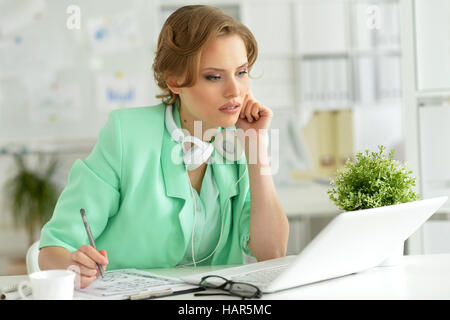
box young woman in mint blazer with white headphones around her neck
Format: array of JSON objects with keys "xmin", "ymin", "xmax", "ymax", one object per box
[{"xmin": 39, "ymin": 5, "xmax": 289, "ymax": 288}]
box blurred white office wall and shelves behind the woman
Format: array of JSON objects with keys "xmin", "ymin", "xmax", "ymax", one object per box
[{"xmin": 0, "ymin": 0, "xmax": 450, "ymax": 275}]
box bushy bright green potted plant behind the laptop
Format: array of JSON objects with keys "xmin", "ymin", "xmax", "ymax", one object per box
[{"xmin": 328, "ymin": 146, "xmax": 420, "ymax": 265}]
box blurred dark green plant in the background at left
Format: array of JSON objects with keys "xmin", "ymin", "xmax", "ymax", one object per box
[{"xmin": 4, "ymin": 153, "xmax": 59, "ymax": 246}]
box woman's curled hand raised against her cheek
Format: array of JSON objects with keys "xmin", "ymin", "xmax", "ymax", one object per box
[{"xmin": 235, "ymin": 91, "xmax": 273, "ymax": 131}]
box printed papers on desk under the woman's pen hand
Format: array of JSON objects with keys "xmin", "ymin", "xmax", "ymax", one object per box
[{"xmin": 76, "ymin": 269, "xmax": 197, "ymax": 299}]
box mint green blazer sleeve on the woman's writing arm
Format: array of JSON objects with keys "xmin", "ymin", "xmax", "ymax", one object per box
[{"xmin": 39, "ymin": 111, "xmax": 122, "ymax": 251}]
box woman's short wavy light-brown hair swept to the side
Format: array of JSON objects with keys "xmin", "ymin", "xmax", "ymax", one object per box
[{"xmin": 153, "ymin": 5, "xmax": 258, "ymax": 105}]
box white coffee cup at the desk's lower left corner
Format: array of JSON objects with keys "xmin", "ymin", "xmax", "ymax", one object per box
[{"xmin": 18, "ymin": 270, "xmax": 75, "ymax": 300}]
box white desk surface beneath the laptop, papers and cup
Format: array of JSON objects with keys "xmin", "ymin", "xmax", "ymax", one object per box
[{"xmin": 0, "ymin": 254, "xmax": 450, "ymax": 300}]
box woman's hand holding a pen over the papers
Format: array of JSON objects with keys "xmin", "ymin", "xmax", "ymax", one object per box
[{"xmin": 70, "ymin": 245, "xmax": 109, "ymax": 289}]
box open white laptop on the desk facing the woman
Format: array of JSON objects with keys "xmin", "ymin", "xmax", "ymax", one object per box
[{"xmin": 181, "ymin": 196, "xmax": 448, "ymax": 293}]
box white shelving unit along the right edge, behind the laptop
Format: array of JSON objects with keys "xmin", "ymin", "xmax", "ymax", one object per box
[{"xmin": 400, "ymin": 0, "xmax": 450, "ymax": 254}]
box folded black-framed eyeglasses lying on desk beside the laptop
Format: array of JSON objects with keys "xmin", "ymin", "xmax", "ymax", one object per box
[{"xmin": 194, "ymin": 275, "xmax": 262, "ymax": 299}]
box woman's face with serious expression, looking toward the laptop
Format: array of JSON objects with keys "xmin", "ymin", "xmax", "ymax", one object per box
[{"xmin": 172, "ymin": 35, "xmax": 249, "ymax": 130}]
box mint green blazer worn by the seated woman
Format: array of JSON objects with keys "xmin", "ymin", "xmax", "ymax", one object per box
[{"xmin": 40, "ymin": 104, "xmax": 251, "ymax": 270}]
